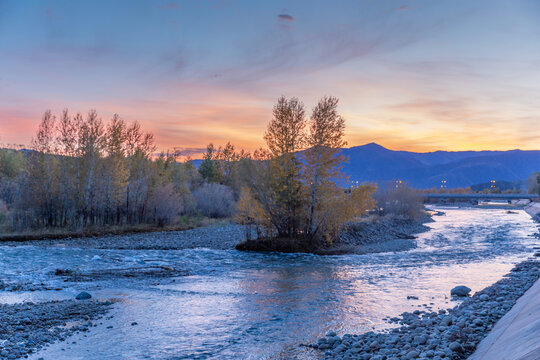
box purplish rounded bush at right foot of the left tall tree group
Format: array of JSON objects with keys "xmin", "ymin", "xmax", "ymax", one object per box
[{"xmin": 149, "ymin": 184, "xmax": 184, "ymax": 226}]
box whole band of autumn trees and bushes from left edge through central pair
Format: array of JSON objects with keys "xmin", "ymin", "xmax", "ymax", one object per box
[{"xmin": 0, "ymin": 96, "xmax": 418, "ymax": 243}]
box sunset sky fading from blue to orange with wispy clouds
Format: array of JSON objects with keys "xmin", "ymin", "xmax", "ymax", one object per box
[{"xmin": 0, "ymin": 0, "xmax": 540, "ymax": 156}]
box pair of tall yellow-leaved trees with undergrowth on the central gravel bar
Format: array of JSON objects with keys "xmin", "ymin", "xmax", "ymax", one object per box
[{"xmin": 243, "ymin": 97, "xmax": 376, "ymax": 249}]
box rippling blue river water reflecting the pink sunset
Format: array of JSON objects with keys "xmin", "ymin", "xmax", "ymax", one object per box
[{"xmin": 0, "ymin": 207, "xmax": 537, "ymax": 359}]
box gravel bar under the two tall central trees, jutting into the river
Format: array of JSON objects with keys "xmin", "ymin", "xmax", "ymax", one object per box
[{"xmin": 236, "ymin": 214, "xmax": 433, "ymax": 255}]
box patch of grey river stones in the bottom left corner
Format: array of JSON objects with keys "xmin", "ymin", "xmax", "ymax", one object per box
[{"xmin": 0, "ymin": 300, "xmax": 112, "ymax": 359}]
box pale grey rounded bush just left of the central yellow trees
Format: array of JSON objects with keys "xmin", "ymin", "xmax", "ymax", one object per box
[{"xmin": 193, "ymin": 183, "xmax": 236, "ymax": 218}]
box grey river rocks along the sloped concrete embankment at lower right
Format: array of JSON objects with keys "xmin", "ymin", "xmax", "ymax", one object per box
[{"xmin": 308, "ymin": 260, "xmax": 540, "ymax": 360}]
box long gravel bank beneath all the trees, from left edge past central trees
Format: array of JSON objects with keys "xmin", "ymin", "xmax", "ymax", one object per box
[{"xmin": 0, "ymin": 215, "xmax": 432, "ymax": 255}]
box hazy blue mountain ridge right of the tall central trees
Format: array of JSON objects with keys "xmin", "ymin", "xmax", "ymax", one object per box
[{"xmin": 343, "ymin": 143, "xmax": 540, "ymax": 188}]
